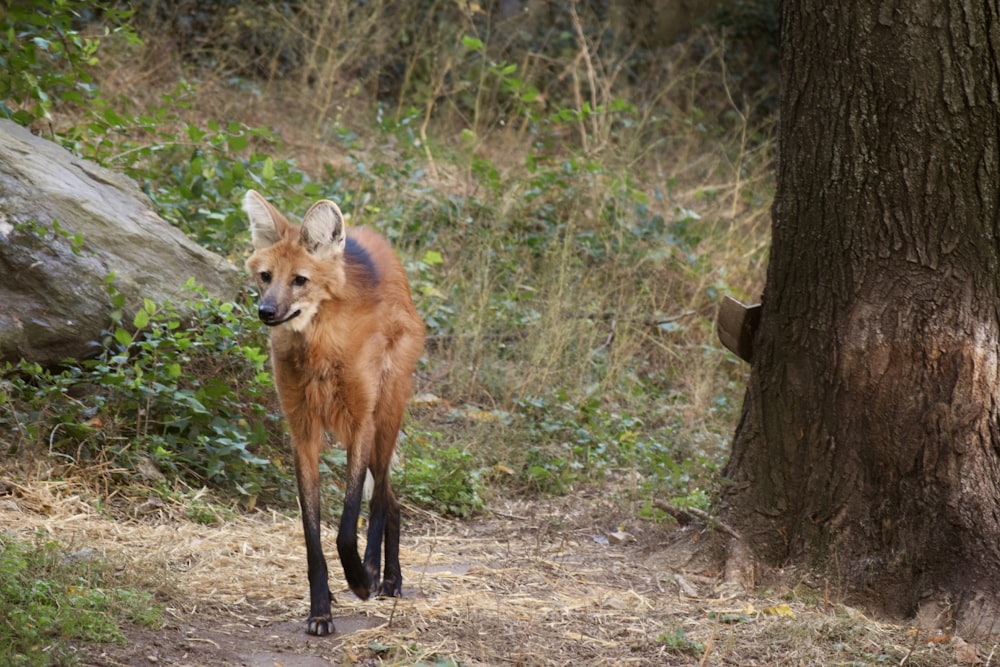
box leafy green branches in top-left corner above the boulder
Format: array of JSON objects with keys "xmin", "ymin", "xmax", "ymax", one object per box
[{"xmin": 0, "ymin": 0, "xmax": 135, "ymax": 125}]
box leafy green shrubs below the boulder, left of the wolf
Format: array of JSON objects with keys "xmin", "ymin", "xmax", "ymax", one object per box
[{"xmin": 0, "ymin": 278, "xmax": 281, "ymax": 503}]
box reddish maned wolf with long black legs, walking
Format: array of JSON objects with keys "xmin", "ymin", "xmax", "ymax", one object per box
[{"xmin": 243, "ymin": 190, "xmax": 424, "ymax": 635}]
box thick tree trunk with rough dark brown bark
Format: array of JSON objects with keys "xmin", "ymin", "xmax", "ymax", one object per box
[{"xmin": 722, "ymin": 0, "xmax": 1000, "ymax": 633}]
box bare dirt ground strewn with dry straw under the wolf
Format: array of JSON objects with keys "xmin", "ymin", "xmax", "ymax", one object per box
[{"xmin": 0, "ymin": 479, "xmax": 984, "ymax": 667}]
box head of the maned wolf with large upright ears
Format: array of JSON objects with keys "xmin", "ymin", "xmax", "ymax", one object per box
[{"xmin": 243, "ymin": 190, "xmax": 347, "ymax": 331}]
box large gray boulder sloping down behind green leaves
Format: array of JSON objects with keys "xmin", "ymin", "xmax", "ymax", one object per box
[{"xmin": 0, "ymin": 120, "xmax": 242, "ymax": 365}]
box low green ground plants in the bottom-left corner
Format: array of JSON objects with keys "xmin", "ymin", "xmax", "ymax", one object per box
[{"xmin": 0, "ymin": 534, "xmax": 163, "ymax": 667}]
